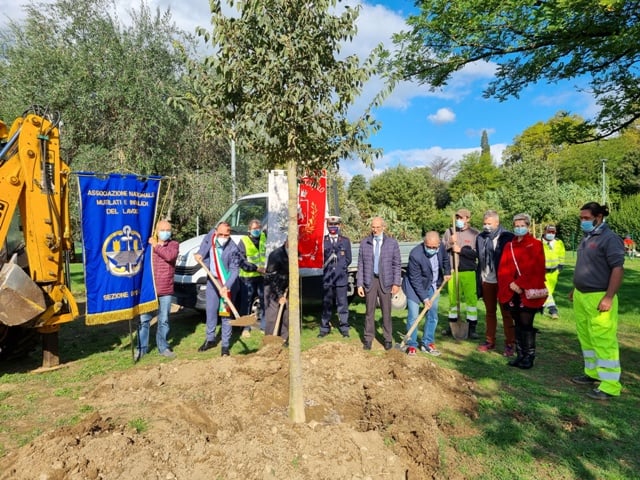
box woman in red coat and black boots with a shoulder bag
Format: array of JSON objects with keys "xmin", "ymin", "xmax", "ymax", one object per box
[{"xmin": 498, "ymin": 213, "xmax": 547, "ymax": 369}]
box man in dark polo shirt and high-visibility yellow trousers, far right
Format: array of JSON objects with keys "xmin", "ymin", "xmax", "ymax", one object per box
[{"xmin": 570, "ymin": 202, "xmax": 624, "ymax": 400}]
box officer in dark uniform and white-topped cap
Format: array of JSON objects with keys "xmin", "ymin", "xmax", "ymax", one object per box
[{"xmin": 318, "ymin": 215, "xmax": 351, "ymax": 338}]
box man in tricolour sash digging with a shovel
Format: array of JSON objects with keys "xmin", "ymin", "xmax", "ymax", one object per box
[{"xmin": 195, "ymin": 222, "xmax": 240, "ymax": 356}]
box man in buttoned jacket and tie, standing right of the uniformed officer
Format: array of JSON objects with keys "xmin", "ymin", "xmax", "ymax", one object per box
[{"xmin": 356, "ymin": 217, "xmax": 402, "ymax": 350}]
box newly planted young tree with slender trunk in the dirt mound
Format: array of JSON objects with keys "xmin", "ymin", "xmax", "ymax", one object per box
[{"xmin": 176, "ymin": 0, "xmax": 379, "ymax": 422}]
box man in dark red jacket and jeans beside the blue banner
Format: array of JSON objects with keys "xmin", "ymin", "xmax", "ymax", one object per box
[{"xmin": 135, "ymin": 220, "xmax": 179, "ymax": 362}]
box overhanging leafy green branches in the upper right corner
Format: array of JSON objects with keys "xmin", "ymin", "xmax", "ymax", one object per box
[{"xmin": 392, "ymin": 0, "xmax": 640, "ymax": 140}]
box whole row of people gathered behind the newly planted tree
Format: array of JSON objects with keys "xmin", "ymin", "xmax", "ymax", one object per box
[{"xmin": 136, "ymin": 202, "xmax": 625, "ymax": 400}]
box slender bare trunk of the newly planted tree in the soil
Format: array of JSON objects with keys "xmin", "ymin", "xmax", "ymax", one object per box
[{"xmin": 287, "ymin": 160, "xmax": 305, "ymax": 423}]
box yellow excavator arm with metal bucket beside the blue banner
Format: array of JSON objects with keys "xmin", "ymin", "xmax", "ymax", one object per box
[{"xmin": 0, "ymin": 106, "xmax": 79, "ymax": 368}]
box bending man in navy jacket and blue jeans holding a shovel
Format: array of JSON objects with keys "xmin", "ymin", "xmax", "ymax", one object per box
[{"xmin": 402, "ymin": 231, "xmax": 451, "ymax": 356}]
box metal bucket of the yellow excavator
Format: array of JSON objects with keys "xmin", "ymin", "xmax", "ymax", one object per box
[{"xmin": 0, "ymin": 263, "xmax": 47, "ymax": 327}]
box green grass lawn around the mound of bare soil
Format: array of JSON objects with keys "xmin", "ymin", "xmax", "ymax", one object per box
[{"xmin": 0, "ymin": 253, "xmax": 640, "ymax": 480}]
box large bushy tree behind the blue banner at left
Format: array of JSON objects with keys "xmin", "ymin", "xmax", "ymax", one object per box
[{"xmin": 0, "ymin": 0, "xmax": 218, "ymax": 236}]
